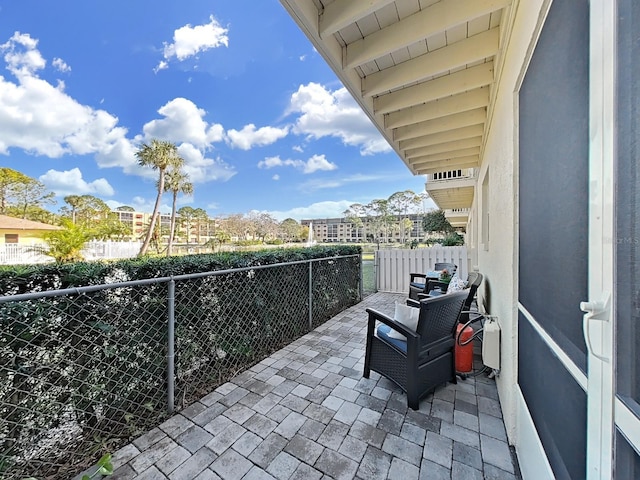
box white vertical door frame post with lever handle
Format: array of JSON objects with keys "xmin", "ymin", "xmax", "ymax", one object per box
[{"xmin": 580, "ymin": 0, "xmax": 617, "ymax": 480}]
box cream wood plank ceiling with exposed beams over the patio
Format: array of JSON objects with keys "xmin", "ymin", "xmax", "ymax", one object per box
[{"xmin": 280, "ymin": 0, "xmax": 511, "ymax": 175}]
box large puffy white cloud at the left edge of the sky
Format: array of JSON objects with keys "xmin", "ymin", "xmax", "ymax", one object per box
[{"xmin": 0, "ymin": 32, "xmax": 135, "ymax": 171}]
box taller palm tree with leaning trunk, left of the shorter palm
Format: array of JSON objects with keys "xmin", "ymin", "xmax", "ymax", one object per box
[{"xmin": 136, "ymin": 138, "xmax": 184, "ymax": 256}]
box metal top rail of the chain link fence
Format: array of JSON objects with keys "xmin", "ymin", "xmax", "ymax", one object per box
[{"xmin": 0, "ymin": 254, "xmax": 360, "ymax": 304}]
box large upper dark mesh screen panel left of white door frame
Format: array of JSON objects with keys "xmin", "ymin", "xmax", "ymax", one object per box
[{"xmin": 519, "ymin": 0, "xmax": 589, "ymax": 370}]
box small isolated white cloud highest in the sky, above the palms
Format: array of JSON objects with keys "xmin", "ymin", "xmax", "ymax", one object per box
[{"xmin": 156, "ymin": 15, "xmax": 229, "ymax": 71}]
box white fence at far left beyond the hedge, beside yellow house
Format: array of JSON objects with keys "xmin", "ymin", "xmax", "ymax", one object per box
[{"xmin": 0, "ymin": 241, "xmax": 142, "ymax": 265}]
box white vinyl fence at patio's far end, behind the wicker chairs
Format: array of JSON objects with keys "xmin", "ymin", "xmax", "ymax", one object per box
[{"xmin": 375, "ymin": 246, "xmax": 469, "ymax": 294}]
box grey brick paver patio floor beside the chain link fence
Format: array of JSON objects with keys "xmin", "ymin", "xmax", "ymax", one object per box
[{"xmin": 110, "ymin": 293, "xmax": 519, "ymax": 480}]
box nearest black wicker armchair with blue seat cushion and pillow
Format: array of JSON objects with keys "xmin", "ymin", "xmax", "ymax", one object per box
[{"xmin": 363, "ymin": 291, "xmax": 468, "ymax": 410}]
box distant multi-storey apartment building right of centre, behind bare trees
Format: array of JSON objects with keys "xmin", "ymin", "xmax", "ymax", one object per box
[{"xmin": 300, "ymin": 213, "xmax": 425, "ymax": 243}]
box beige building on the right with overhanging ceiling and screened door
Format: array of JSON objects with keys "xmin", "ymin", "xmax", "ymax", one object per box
[{"xmin": 281, "ymin": 0, "xmax": 640, "ymax": 480}]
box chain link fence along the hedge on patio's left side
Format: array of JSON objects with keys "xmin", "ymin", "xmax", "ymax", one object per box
[{"xmin": 0, "ymin": 255, "xmax": 362, "ymax": 480}]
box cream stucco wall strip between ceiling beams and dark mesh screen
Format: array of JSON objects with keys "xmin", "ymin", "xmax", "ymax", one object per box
[{"xmin": 470, "ymin": 0, "xmax": 549, "ymax": 446}]
